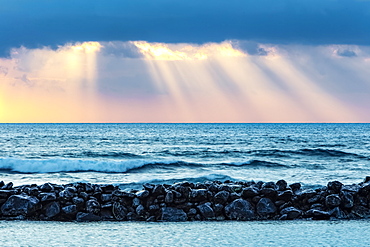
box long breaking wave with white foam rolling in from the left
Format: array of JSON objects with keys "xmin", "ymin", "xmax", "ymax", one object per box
[{"xmin": 0, "ymin": 158, "xmax": 288, "ymax": 173}]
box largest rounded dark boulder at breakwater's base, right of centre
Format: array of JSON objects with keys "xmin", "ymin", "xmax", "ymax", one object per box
[{"xmin": 225, "ymin": 199, "xmax": 255, "ymax": 220}]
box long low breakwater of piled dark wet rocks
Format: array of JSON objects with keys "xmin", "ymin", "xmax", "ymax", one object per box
[{"xmin": 0, "ymin": 177, "xmax": 370, "ymax": 221}]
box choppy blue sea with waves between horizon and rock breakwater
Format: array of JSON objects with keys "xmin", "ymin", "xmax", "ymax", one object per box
[{"xmin": 0, "ymin": 124, "xmax": 370, "ymax": 188}]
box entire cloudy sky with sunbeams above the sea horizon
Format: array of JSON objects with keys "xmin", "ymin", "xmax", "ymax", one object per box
[{"xmin": 0, "ymin": 0, "xmax": 370, "ymax": 123}]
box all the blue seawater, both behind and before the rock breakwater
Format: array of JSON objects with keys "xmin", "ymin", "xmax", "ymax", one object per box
[{"xmin": 0, "ymin": 124, "xmax": 370, "ymax": 246}]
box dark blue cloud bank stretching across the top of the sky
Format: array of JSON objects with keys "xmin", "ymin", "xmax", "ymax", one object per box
[{"xmin": 0, "ymin": 0, "xmax": 370, "ymax": 55}]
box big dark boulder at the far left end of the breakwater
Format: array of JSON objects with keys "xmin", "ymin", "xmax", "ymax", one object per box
[{"xmin": 1, "ymin": 195, "xmax": 41, "ymax": 216}]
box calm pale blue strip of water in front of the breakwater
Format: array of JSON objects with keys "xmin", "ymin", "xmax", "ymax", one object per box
[{"xmin": 0, "ymin": 220, "xmax": 370, "ymax": 246}]
